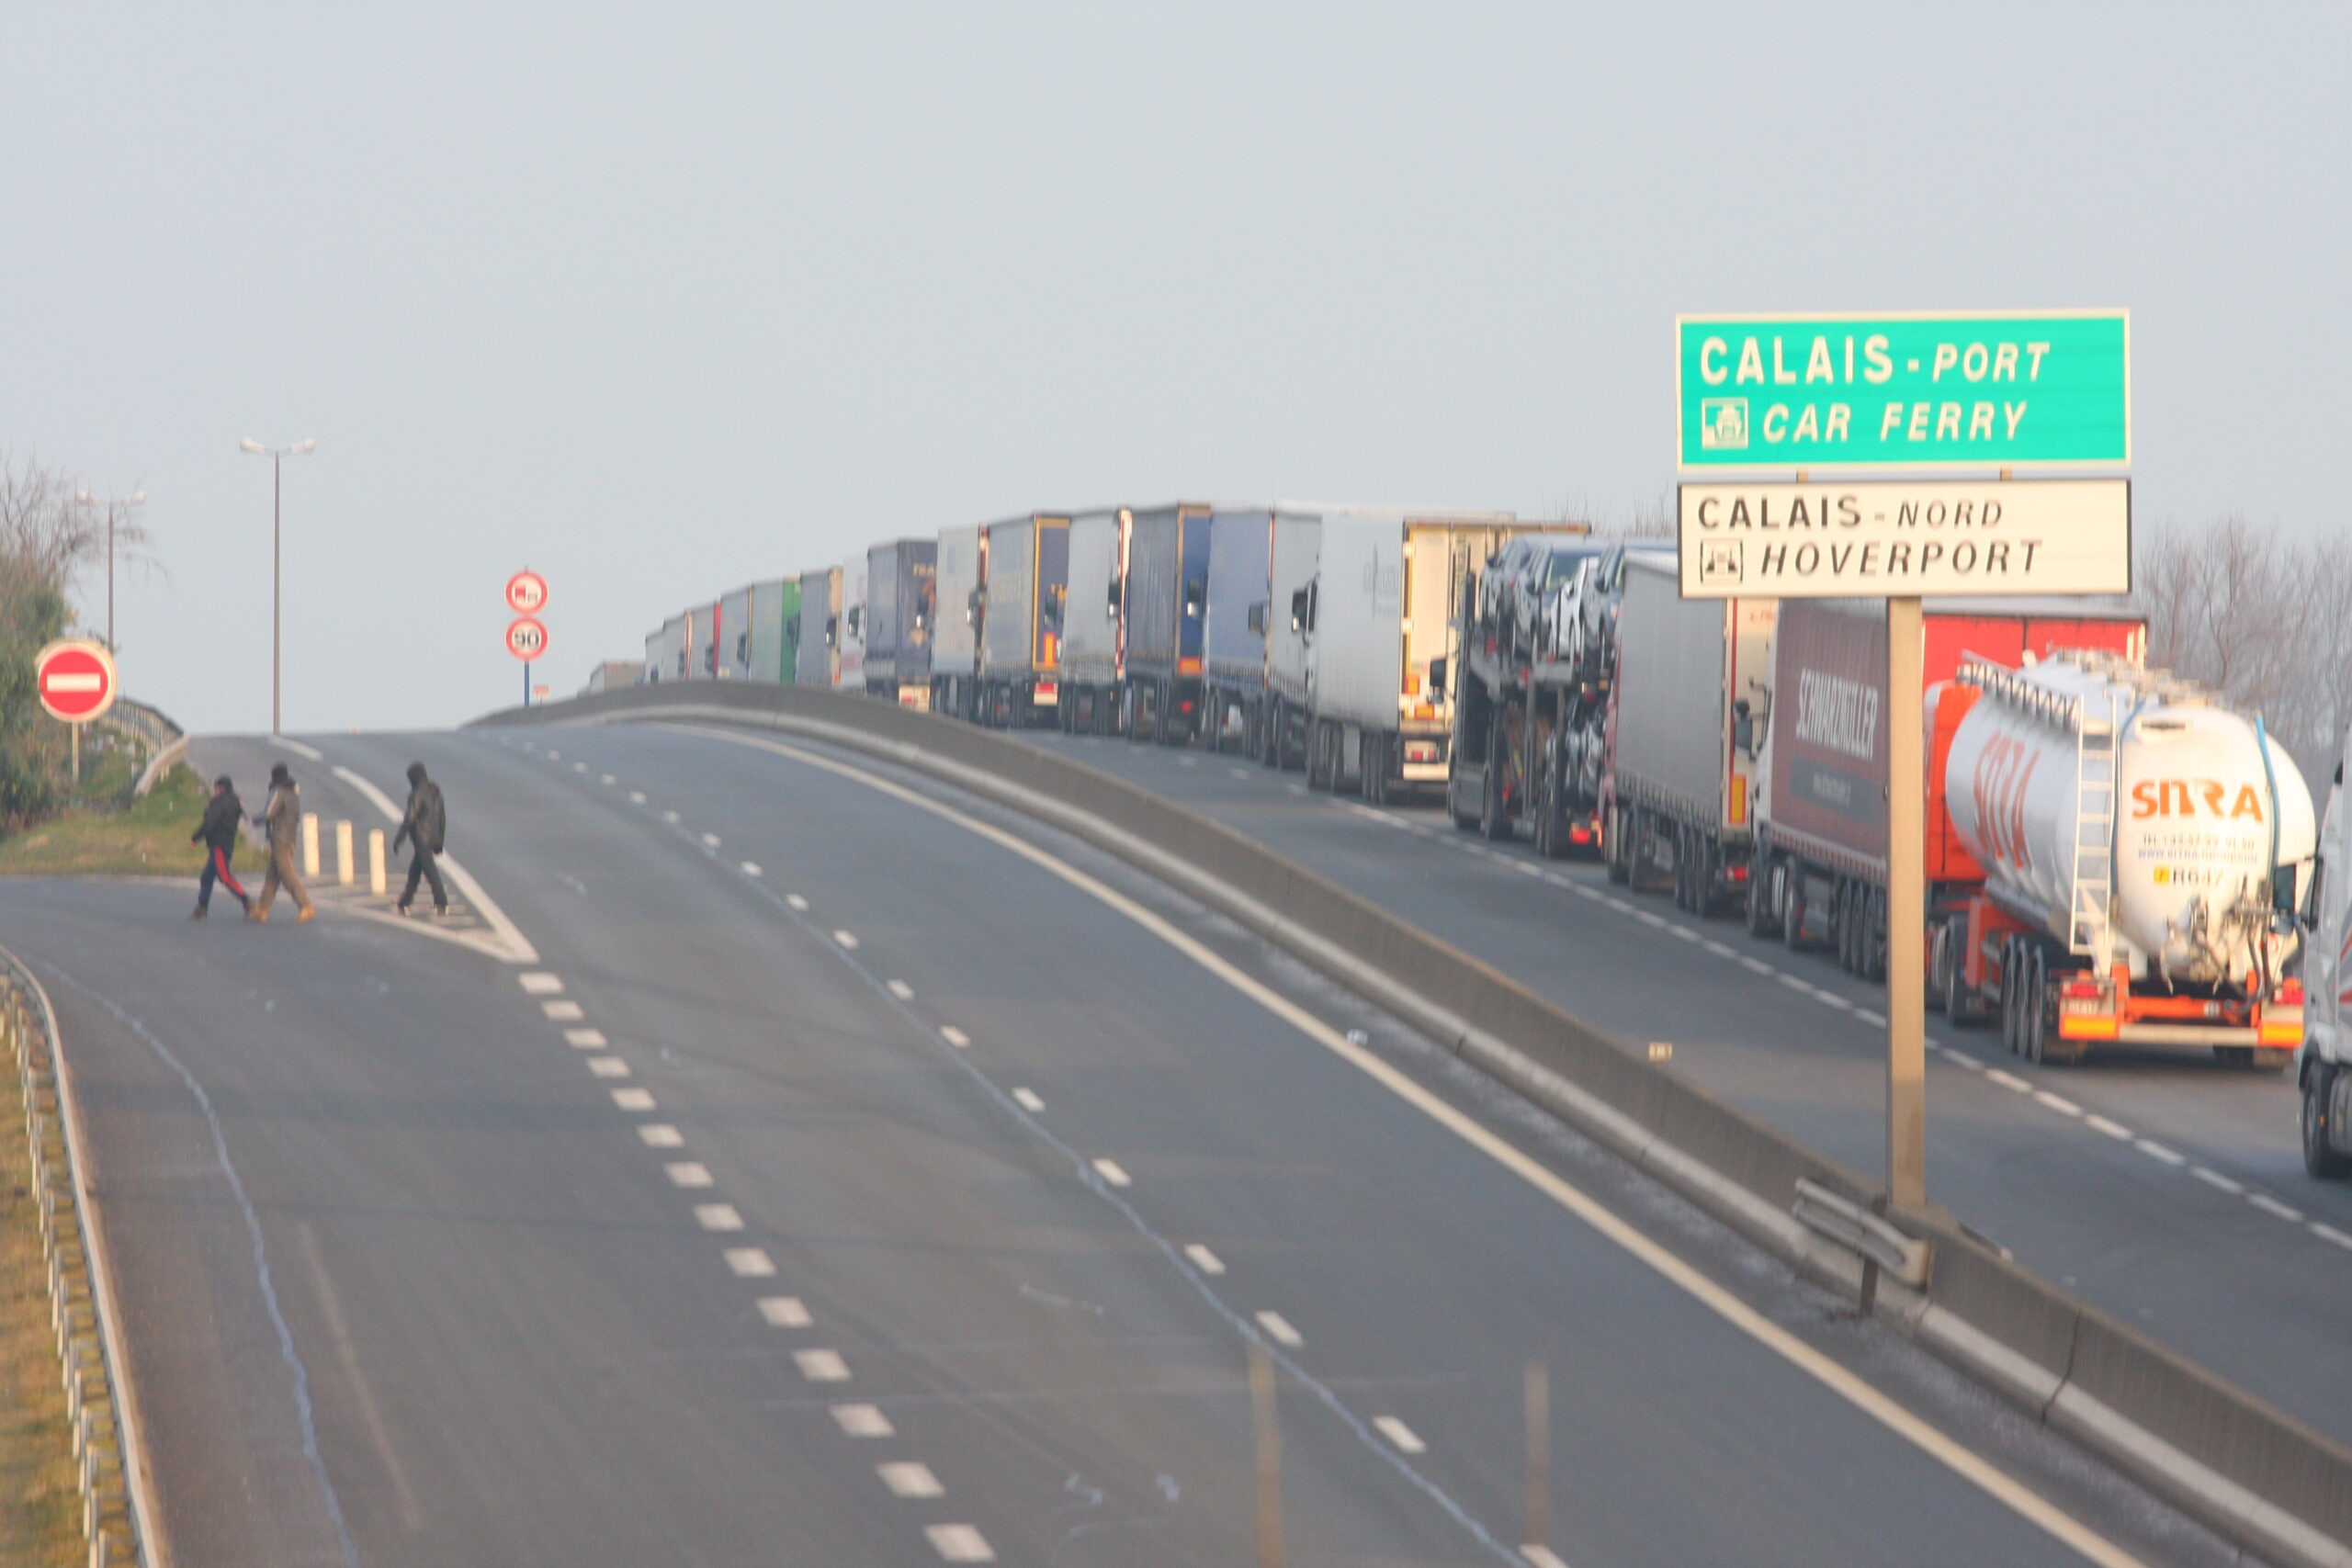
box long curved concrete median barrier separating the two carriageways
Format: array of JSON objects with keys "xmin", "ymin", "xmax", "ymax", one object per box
[{"xmin": 478, "ymin": 682, "xmax": 2352, "ymax": 1568}]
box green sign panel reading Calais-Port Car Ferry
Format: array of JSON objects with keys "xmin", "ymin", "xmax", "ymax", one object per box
[{"xmin": 1675, "ymin": 310, "xmax": 2131, "ymax": 468}]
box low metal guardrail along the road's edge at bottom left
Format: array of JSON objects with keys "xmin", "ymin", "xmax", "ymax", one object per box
[{"xmin": 0, "ymin": 950, "xmax": 151, "ymax": 1568}]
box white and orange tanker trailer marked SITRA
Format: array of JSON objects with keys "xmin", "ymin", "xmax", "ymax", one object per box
[{"xmin": 1928, "ymin": 651, "xmax": 2319, "ymax": 1072}]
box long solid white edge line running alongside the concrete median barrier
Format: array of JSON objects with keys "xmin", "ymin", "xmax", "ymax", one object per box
[{"xmin": 694, "ymin": 728, "xmax": 2143, "ymax": 1568}]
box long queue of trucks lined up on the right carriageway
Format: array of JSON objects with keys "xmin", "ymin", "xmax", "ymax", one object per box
[{"xmin": 644, "ymin": 501, "xmax": 2324, "ymax": 1123}]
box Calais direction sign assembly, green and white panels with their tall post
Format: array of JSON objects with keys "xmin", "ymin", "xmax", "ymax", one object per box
[{"xmin": 1675, "ymin": 310, "xmax": 2131, "ymax": 1211}]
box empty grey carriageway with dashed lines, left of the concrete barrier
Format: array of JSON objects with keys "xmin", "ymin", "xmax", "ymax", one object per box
[{"xmin": 0, "ymin": 728, "xmax": 2232, "ymax": 1568}]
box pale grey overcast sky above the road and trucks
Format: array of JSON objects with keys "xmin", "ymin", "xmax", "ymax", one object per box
[{"xmin": 0, "ymin": 0, "xmax": 2352, "ymax": 731}]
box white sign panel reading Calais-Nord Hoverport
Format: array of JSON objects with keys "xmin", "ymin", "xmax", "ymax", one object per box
[{"xmin": 1679, "ymin": 479, "xmax": 2131, "ymax": 600}]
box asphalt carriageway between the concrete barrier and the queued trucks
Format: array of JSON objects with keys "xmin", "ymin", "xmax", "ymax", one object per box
[{"xmin": 1011, "ymin": 733, "xmax": 2352, "ymax": 1441}]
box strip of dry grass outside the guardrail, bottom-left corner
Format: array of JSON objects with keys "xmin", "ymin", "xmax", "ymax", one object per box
[{"xmin": 0, "ymin": 1058, "xmax": 89, "ymax": 1568}]
